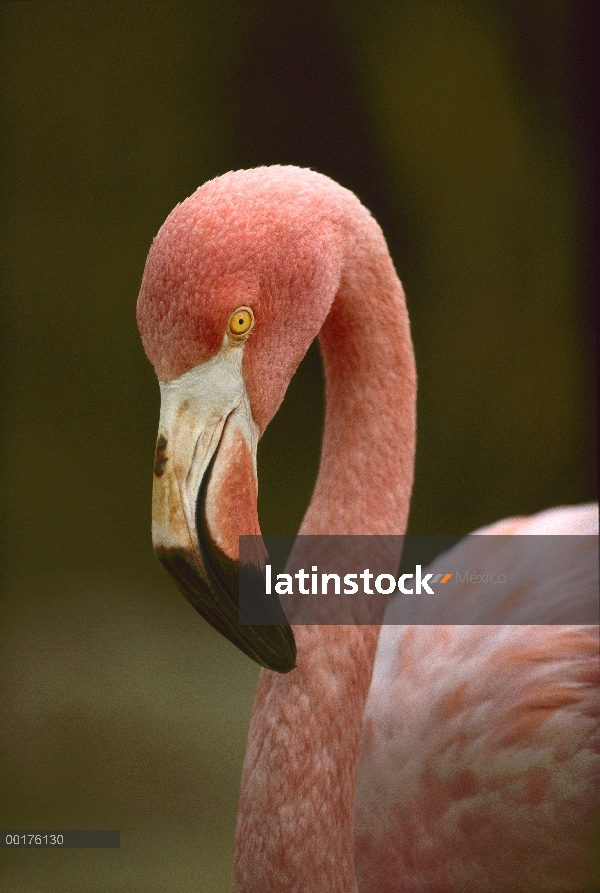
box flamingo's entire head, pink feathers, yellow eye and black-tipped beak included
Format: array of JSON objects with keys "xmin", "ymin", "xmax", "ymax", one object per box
[{"xmin": 137, "ymin": 167, "xmax": 346, "ymax": 672}]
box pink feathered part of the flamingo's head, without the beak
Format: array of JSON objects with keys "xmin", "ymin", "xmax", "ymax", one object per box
[{"xmin": 137, "ymin": 166, "xmax": 370, "ymax": 433}]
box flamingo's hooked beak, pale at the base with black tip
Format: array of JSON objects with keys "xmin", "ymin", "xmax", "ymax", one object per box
[{"xmin": 152, "ymin": 342, "xmax": 296, "ymax": 673}]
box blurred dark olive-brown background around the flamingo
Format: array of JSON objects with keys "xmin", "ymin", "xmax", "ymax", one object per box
[{"xmin": 0, "ymin": 0, "xmax": 596, "ymax": 893}]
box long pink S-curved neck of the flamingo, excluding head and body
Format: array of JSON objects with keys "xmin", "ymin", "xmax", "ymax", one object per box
[{"xmin": 233, "ymin": 218, "xmax": 416, "ymax": 893}]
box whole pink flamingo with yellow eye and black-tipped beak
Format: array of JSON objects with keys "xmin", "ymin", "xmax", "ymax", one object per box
[{"xmin": 137, "ymin": 166, "xmax": 600, "ymax": 893}]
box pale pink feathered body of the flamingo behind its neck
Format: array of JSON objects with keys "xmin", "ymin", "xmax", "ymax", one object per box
[{"xmin": 355, "ymin": 506, "xmax": 600, "ymax": 893}]
